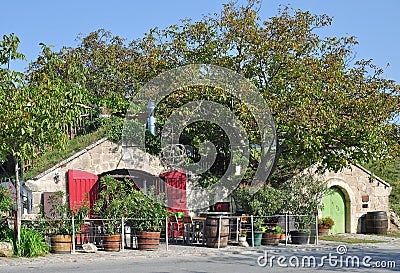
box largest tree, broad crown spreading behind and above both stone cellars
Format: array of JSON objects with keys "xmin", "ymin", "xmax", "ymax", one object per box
[{"xmin": 60, "ymin": 1, "xmax": 400, "ymax": 181}]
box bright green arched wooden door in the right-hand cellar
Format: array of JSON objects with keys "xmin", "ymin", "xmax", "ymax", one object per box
[{"xmin": 322, "ymin": 188, "xmax": 346, "ymax": 234}]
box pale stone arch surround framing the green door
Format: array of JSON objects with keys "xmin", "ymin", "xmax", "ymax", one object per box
[{"xmin": 320, "ymin": 178, "xmax": 357, "ymax": 233}]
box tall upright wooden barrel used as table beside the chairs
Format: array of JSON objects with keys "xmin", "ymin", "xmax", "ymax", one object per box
[{"xmin": 204, "ymin": 215, "xmax": 229, "ymax": 247}]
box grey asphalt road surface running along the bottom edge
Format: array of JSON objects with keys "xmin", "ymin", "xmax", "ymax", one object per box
[{"xmin": 0, "ymin": 247, "xmax": 400, "ymax": 273}]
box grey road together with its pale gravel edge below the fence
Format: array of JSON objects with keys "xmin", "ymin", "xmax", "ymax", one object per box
[{"xmin": 0, "ymin": 234, "xmax": 400, "ymax": 273}]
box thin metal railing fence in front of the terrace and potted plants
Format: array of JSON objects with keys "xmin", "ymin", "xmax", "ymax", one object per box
[{"xmin": 11, "ymin": 214, "xmax": 318, "ymax": 253}]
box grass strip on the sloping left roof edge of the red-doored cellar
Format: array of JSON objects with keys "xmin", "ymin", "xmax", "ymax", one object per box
[{"xmin": 24, "ymin": 129, "xmax": 104, "ymax": 179}]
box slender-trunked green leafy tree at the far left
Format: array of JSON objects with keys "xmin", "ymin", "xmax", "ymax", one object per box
[{"xmin": 0, "ymin": 35, "xmax": 88, "ymax": 240}]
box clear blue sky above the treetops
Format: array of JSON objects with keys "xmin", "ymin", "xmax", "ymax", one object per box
[{"xmin": 0, "ymin": 0, "xmax": 400, "ymax": 82}]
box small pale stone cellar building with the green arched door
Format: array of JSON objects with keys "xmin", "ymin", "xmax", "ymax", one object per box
[{"xmin": 311, "ymin": 165, "xmax": 392, "ymax": 233}]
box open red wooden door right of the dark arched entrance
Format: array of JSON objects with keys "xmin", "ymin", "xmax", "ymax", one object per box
[{"xmin": 160, "ymin": 171, "xmax": 187, "ymax": 211}]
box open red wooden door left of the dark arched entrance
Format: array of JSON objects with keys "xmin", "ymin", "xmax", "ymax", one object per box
[{"xmin": 68, "ymin": 170, "xmax": 99, "ymax": 209}]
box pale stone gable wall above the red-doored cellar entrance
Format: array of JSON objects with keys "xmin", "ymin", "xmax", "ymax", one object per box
[{"xmin": 26, "ymin": 138, "xmax": 164, "ymax": 213}]
